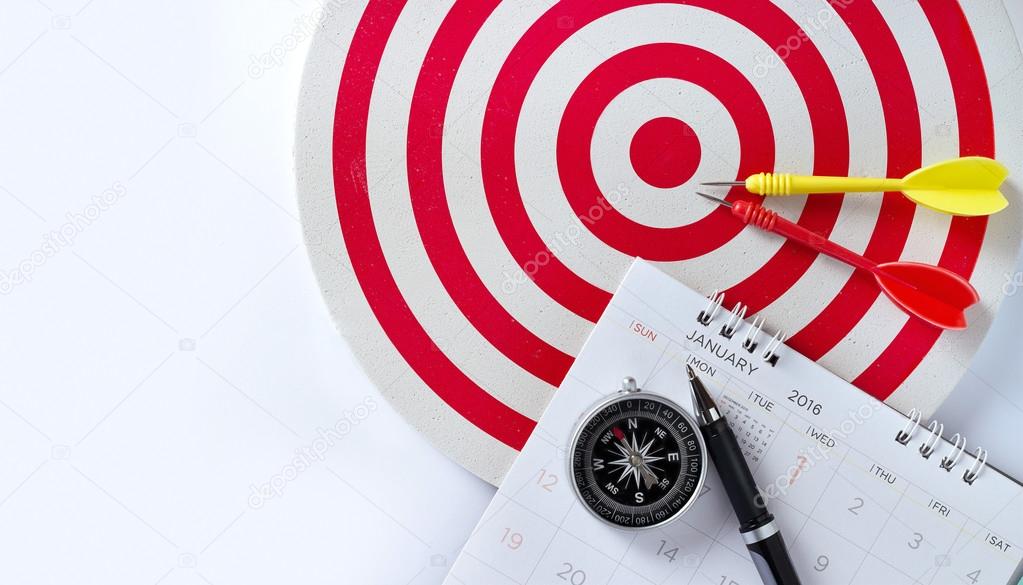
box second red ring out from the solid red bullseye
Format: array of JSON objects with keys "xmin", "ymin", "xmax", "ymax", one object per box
[{"xmin": 481, "ymin": 0, "xmax": 849, "ymax": 320}]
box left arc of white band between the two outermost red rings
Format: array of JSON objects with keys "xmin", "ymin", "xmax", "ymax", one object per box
[{"xmin": 366, "ymin": 3, "xmax": 553, "ymax": 419}]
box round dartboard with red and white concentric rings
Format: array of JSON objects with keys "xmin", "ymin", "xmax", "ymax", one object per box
[{"xmin": 297, "ymin": 0, "xmax": 1023, "ymax": 482}]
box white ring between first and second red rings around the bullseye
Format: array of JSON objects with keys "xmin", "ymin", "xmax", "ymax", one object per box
[{"xmin": 516, "ymin": 4, "xmax": 811, "ymax": 290}]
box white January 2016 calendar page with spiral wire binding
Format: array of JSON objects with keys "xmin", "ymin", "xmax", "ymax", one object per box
[{"xmin": 445, "ymin": 261, "xmax": 1023, "ymax": 585}]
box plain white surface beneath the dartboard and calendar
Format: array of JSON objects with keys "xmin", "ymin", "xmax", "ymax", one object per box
[{"xmin": 0, "ymin": 0, "xmax": 1023, "ymax": 585}]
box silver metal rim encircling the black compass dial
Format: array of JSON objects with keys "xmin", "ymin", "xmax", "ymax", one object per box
[{"xmin": 566, "ymin": 389, "xmax": 710, "ymax": 531}]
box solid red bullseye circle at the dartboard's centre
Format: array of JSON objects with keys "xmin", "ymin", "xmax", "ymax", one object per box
[{"xmin": 629, "ymin": 117, "xmax": 702, "ymax": 189}]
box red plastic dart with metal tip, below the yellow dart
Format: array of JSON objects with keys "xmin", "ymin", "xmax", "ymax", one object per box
[{"xmin": 697, "ymin": 193, "xmax": 980, "ymax": 329}]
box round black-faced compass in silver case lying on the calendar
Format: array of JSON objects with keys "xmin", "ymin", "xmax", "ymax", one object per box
[{"xmin": 570, "ymin": 377, "xmax": 707, "ymax": 528}]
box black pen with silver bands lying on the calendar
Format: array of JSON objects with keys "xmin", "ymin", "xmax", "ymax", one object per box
[{"xmin": 685, "ymin": 365, "xmax": 800, "ymax": 585}]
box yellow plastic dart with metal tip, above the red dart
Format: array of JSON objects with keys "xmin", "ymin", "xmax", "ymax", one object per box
[{"xmin": 704, "ymin": 156, "xmax": 1009, "ymax": 216}]
